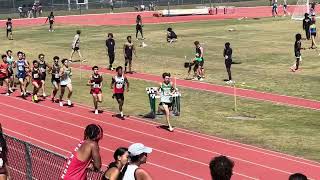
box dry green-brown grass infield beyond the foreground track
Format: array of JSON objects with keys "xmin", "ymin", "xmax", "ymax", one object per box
[{"xmin": 0, "ymin": 18, "xmax": 320, "ymax": 161}]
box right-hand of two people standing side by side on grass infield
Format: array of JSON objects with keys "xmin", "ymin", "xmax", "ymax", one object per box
[{"xmin": 123, "ymin": 36, "xmax": 137, "ymax": 74}]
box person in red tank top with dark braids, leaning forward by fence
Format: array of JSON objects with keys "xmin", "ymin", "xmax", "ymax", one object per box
[{"xmin": 61, "ymin": 124, "xmax": 103, "ymax": 180}]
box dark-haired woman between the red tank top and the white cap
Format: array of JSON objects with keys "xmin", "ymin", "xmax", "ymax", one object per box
[{"xmin": 101, "ymin": 147, "xmax": 129, "ymax": 180}]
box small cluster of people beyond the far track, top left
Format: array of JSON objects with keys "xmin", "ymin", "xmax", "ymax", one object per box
[{"xmin": 18, "ymin": 2, "xmax": 43, "ymax": 18}]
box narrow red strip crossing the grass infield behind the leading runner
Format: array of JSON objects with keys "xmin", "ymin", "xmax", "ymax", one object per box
[{"xmin": 73, "ymin": 64, "xmax": 320, "ymax": 110}]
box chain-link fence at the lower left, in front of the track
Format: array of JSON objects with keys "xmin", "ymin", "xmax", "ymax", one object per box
[{"xmin": 4, "ymin": 135, "xmax": 102, "ymax": 180}]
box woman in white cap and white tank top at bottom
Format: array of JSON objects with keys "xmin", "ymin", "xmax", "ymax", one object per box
[{"xmin": 123, "ymin": 143, "xmax": 152, "ymax": 180}]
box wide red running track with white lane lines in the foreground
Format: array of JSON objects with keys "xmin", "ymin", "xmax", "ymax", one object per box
[{"xmin": 0, "ymin": 90, "xmax": 320, "ymax": 180}]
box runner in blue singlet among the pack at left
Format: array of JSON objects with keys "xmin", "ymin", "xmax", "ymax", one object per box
[{"xmin": 17, "ymin": 51, "xmax": 28, "ymax": 97}]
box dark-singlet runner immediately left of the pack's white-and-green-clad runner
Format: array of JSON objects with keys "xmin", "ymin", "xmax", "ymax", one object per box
[{"xmin": 49, "ymin": 56, "xmax": 60, "ymax": 102}]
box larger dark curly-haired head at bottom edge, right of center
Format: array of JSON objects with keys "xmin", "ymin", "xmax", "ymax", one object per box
[{"xmin": 209, "ymin": 156, "xmax": 234, "ymax": 180}]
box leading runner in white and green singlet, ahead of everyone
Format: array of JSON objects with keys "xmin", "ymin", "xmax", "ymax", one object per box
[{"xmin": 159, "ymin": 73, "xmax": 175, "ymax": 132}]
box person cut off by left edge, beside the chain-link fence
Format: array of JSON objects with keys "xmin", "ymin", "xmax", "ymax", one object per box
[{"xmin": 0, "ymin": 124, "xmax": 11, "ymax": 180}]
